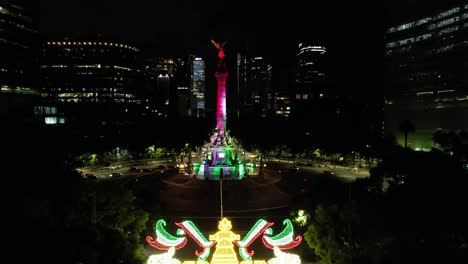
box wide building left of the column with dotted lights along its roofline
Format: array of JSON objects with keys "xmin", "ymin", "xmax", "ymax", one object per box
[{"xmin": 40, "ymin": 40, "xmax": 141, "ymax": 120}]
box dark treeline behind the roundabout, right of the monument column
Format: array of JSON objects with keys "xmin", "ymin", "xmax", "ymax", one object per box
[{"xmin": 228, "ymin": 117, "xmax": 380, "ymax": 153}]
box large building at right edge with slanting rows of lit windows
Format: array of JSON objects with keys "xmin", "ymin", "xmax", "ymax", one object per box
[{"xmin": 385, "ymin": 4, "xmax": 468, "ymax": 149}]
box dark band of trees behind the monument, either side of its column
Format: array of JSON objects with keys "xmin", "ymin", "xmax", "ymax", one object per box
[{"xmin": 8, "ymin": 115, "xmax": 380, "ymax": 155}]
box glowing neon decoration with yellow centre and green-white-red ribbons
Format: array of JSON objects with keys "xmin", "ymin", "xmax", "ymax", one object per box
[{"xmin": 146, "ymin": 218, "xmax": 302, "ymax": 264}]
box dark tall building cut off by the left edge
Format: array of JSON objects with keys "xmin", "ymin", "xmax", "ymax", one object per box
[{"xmin": 0, "ymin": 0, "xmax": 40, "ymax": 115}]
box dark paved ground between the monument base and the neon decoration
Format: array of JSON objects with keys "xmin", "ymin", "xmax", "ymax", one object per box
[{"xmin": 161, "ymin": 169, "xmax": 290, "ymax": 215}]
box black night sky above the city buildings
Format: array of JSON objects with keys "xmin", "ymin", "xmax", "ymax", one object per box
[{"xmin": 40, "ymin": 0, "xmax": 464, "ymax": 103}]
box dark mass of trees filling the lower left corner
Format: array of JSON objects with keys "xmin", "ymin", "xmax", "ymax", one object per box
[{"xmin": 1, "ymin": 120, "xmax": 159, "ymax": 263}]
